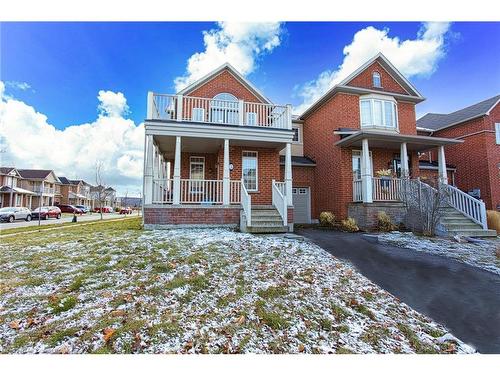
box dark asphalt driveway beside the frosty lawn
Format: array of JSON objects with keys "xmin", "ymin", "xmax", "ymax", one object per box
[{"xmin": 298, "ymin": 228, "xmax": 500, "ymax": 353}]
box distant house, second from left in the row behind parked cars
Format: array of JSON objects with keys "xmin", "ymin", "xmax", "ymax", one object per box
[{"xmin": 17, "ymin": 169, "xmax": 61, "ymax": 209}]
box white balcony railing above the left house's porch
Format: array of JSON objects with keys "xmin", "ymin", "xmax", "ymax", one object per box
[{"xmin": 148, "ymin": 92, "xmax": 292, "ymax": 129}]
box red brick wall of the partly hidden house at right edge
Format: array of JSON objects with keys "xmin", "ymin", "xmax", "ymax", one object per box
[{"xmin": 433, "ymin": 105, "xmax": 500, "ymax": 209}]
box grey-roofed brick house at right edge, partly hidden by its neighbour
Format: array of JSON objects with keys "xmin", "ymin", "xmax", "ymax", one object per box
[{"xmin": 417, "ymin": 95, "xmax": 500, "ymax": 210}]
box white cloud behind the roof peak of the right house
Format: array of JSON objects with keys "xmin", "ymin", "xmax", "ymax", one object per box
[{"xmin": 295, "ymin": 22, "xmax": 450, "ymax": 113}]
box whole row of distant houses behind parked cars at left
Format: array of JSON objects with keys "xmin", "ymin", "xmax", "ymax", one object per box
[{"xmin": 0, "ymin": 167, "xmax": 120, "ymax": 209}]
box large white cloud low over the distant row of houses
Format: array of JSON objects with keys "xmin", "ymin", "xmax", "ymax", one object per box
[{"xmin": 0, "ymin": 81, "xmax": 144, "ymax": 196}]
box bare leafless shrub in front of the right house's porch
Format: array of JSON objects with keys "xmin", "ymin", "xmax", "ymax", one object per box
[{"xmin": 402, "ymin": 179, "xmax": 449, "ymax": 236}]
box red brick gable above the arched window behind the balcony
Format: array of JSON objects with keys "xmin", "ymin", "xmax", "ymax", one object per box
[{"xmin": 188, "ymin": 70, "xmax": 262, "ymax": 103}]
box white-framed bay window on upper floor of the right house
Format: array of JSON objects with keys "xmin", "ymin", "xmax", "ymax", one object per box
[{"xmin": 360, "ymin": 98, "xmax": 398, "ymax": 129}]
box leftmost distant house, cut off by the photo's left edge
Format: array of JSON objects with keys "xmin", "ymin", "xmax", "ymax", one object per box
[{"xmin": 0, "ymin": 167, "xmax": 36, "ymax": 208}]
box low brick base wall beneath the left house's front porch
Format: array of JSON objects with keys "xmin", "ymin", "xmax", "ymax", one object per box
[{"xmin": 144, "ymin": 206, "xmax": 240, "ymax": 225}]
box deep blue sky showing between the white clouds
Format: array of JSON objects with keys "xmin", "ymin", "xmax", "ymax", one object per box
[{"xmin": 0, "ymin": 22, "xmax": 500, "ymax": 128}]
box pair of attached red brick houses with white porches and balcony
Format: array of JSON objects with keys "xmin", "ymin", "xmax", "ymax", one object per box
[{"xmin": 143, "ymin": 54, "xmax": 494, "ymax": 235}]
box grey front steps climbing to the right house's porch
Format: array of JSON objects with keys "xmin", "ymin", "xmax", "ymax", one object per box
[{"xmin": 440, "ymin": 207, "xmax": 497, "ymax": 237}]
